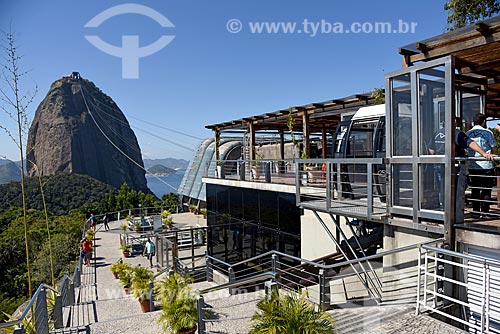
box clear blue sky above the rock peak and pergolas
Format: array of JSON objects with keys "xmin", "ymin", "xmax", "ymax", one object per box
[{"xmin": 0, "ymin": 0, "xmax": 446, "ymax": 160}]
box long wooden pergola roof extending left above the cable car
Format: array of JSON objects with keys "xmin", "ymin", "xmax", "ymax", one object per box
[{"xmin": 205, "ymin": 92, "xmax": 376, "ymax": 132}]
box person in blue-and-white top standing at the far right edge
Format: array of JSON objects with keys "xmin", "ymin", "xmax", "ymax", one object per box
[{"xmin": 467, "ymin": 114, "xmax": 497, "ymax": 217}]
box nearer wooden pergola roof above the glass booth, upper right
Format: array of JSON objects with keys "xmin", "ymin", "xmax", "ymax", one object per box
[{"xmin": 399, "ymin": 16, "xmax": 500, "ymax": 117}]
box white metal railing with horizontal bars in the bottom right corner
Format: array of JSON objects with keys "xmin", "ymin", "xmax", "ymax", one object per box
[{"xmin": 416, "ymin": 245, "xmax": 500, "ymax": 333}]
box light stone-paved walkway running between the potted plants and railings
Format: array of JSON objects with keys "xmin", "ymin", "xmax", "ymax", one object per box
[{"xmin": 78, "ymin": 214, "xmax": 466, "ymax": 334}]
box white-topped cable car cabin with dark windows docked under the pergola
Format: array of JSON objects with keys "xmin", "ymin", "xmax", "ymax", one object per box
[{"xmin": 333, "ymin": 104, "xmax": 386, "ymax": 203}]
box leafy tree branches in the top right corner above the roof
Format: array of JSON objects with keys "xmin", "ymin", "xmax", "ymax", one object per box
[{"xmin": 444, "ymin": 0, "xmax": 500, "ymax": 30}]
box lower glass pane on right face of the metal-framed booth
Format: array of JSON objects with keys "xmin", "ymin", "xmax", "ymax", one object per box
[{"xmin": 420, "ymin": 164, "xmax": 447, "ymax": 211}]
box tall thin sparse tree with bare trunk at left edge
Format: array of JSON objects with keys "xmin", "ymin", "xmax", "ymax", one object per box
[{"xmin": 0, "ymin": 32, "xmax": 37, "ymax": 297}]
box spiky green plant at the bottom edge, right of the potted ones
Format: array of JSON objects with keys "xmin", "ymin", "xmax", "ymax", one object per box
[{"xmin": 250, "ymin": 291, "xmax": 335, "ymax": 334}]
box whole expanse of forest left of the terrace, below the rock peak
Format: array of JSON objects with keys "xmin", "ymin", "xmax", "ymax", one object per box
[{"xmin": 0, "ymin": 173, "xmax": 178, "ymax": 321}]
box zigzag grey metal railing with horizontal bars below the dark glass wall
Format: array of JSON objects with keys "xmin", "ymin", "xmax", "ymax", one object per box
[{"xmin": 203, "ymin": 239, "xmax": 442, "ymax": 308}]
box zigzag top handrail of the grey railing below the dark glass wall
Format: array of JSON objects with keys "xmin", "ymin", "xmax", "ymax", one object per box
[{"xmin": 207, "ymin": 238, "xmax": 444, "ymax": 269}]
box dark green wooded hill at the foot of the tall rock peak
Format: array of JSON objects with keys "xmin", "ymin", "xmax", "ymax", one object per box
[{"xmin": 0, "ymin": 173, "xmax": 112, "ymax": 215}]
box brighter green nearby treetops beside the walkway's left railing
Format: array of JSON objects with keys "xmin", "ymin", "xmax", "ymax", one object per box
[{"xmin": 0, "ymin": 208, "xmax": 85, "ymax": 320}]
